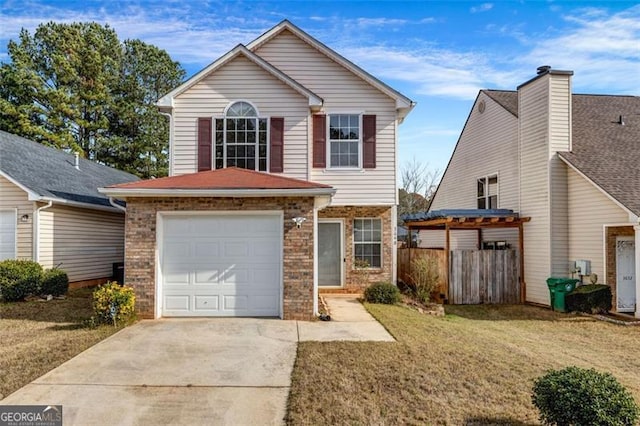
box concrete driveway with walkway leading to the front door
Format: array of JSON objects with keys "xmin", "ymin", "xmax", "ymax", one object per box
[{"xmin": 0, "ymin": 296, "xmax": 393, "ymax": 425}]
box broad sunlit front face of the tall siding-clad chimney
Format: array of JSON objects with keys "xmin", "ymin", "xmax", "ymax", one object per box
[{"xmin": 518, "ymin": 77, "xmax": 551, "ymax": 305}]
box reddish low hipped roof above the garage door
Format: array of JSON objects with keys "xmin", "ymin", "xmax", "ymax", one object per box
[{"xmin": 100, "ymin": 167, "xmax": 335, "ymax": 197}]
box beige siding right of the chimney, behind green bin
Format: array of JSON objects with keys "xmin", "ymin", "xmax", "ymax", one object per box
[{"xmin": 567, "ymin": 168, "xmax": 629, "ymax": 285}]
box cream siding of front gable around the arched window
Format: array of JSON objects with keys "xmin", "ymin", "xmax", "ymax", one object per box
[{"xmin": 173, "ymin": 56, "xmax": 309, "ymax": 179}]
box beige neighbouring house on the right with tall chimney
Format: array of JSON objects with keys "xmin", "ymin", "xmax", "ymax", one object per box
[{"xmin": 420, "ymin": 67, "xmax": 640, "ymax": 316}]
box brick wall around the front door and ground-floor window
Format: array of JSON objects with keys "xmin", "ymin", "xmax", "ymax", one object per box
[{"xmin": 318, "ymin": 206, "xmax": 396, "ymax": 293}]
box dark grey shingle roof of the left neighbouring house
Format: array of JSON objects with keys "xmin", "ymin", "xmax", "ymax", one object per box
[{"xmin": 0, "ymin": 131, "xmax": 138, "ymax": 210}]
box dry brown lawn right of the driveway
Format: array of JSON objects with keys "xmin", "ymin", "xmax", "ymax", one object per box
[{"xmin": 287, "ymin": 305, "xmax": 640, "ymax": 425}]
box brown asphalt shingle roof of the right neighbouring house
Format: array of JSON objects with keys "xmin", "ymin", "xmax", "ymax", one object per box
[{"xmin": 484, "ymin": 90, "xmax": 640, "ymax": 216}]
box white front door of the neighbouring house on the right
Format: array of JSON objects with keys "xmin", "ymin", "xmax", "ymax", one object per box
[{"xmin": 616, "ymin": 237, "xmax": 636, "ymax": 312}]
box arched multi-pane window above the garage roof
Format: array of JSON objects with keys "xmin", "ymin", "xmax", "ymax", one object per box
[{"xmin": 214, "ymin": 101, "xmax": 268, "ymax": 172}]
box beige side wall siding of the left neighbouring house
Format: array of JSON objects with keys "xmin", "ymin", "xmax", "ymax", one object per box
[{"xmin": 40, "ymin": 205, "xmax": 124, "ymax": 282}]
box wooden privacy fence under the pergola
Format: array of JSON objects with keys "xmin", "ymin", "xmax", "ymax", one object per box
[{"xmin": 398, "ymin": 248, "xmax": 520, "ymax": 305}]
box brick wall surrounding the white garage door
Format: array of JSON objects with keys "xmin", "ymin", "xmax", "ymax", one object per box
[{"xmin": 125, "ymin": 197, "xmax": 313, "ymax": 320}]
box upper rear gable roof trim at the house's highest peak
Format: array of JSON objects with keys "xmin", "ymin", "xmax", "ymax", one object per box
[{"xmin": 247, "ymin": 19, "xmax": 415, "ymax": 120}]
